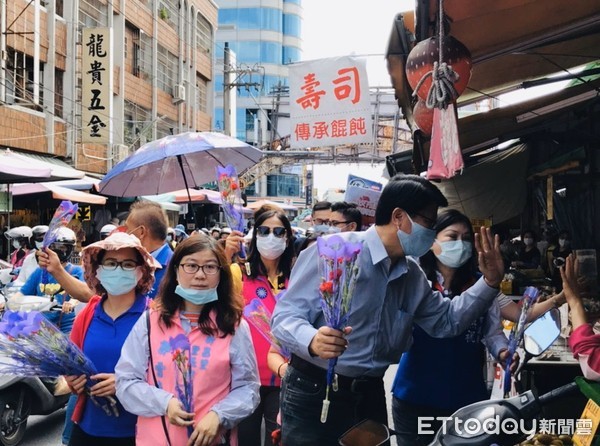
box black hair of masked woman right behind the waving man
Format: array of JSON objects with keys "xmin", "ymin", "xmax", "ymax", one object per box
[{"xmin": 419, "ymin": 209, "xmax": 477, "ymax": 295}]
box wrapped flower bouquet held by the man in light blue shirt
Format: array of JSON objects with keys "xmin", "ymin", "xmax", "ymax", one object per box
[{"xmin": 317, "ymin": 235, "xmax": 362, "ymax": 423}]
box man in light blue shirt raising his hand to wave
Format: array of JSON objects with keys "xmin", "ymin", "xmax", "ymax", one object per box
[{"xmin": 271, "ymin": 175, "xmax": 504, "ymax": 446}]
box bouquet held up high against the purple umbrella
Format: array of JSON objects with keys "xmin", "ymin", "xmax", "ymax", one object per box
[{"xmin": 217, "ymin": 164, "xmax": 246, "ymax": 259}]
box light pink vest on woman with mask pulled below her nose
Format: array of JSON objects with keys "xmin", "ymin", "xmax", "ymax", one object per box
[{"xmin": 136, "ymin": 310, "xmax": 238, "ymax": 446}]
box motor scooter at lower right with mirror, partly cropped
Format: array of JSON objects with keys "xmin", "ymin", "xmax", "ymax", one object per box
[{"xmin": 339, "ymin": 309, "xmax": 578, "ymax": 446}]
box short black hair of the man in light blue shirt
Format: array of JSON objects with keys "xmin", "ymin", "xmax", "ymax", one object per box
[{"xmin": 375, "ymin": 174, "xmax": 448, "ymax": 225}]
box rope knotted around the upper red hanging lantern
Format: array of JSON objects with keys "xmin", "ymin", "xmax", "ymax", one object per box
[{"xmin": 412, "ymin": 0, "xmax": 460, "ymax": 109}]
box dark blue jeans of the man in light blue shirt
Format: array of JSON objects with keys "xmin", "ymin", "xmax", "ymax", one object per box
[{"xmin": 281, "ymin": 365, "xmax": 387, "ymax": 446}]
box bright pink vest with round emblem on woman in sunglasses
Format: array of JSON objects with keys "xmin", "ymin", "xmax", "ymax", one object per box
[{"xmin": 242, "ymin": 275, "xmax": 287, "ymax": 387}]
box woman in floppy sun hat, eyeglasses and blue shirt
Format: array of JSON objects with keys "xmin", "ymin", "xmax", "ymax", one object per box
[{"xmin": 66, "ymin": 232, "xmax": 158, "ymax": 446}]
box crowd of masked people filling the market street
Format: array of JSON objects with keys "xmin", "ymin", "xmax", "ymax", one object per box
[{"xmin": 0, "ymin": 175, "xmax": 600, "ymax": 446}]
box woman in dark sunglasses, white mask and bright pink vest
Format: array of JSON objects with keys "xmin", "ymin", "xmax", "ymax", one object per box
[{"xmin": 232, "ymin": 208, "xmax": 294, "ymax": 446}]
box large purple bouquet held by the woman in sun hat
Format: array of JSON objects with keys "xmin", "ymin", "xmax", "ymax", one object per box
[{"xmin": 0, "ymin": 310, "xmax": 119, "ymax": 416}]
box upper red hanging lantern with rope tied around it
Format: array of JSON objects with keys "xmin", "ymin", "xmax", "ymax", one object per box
[{"xmin": 406, "ymin": 36, "xmax": 472, "ymax": 100}]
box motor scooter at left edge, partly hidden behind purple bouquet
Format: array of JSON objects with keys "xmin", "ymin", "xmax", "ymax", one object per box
[{"xmin": 0, "ymin": 296, "xmax": 71, "ymax": 446}]
